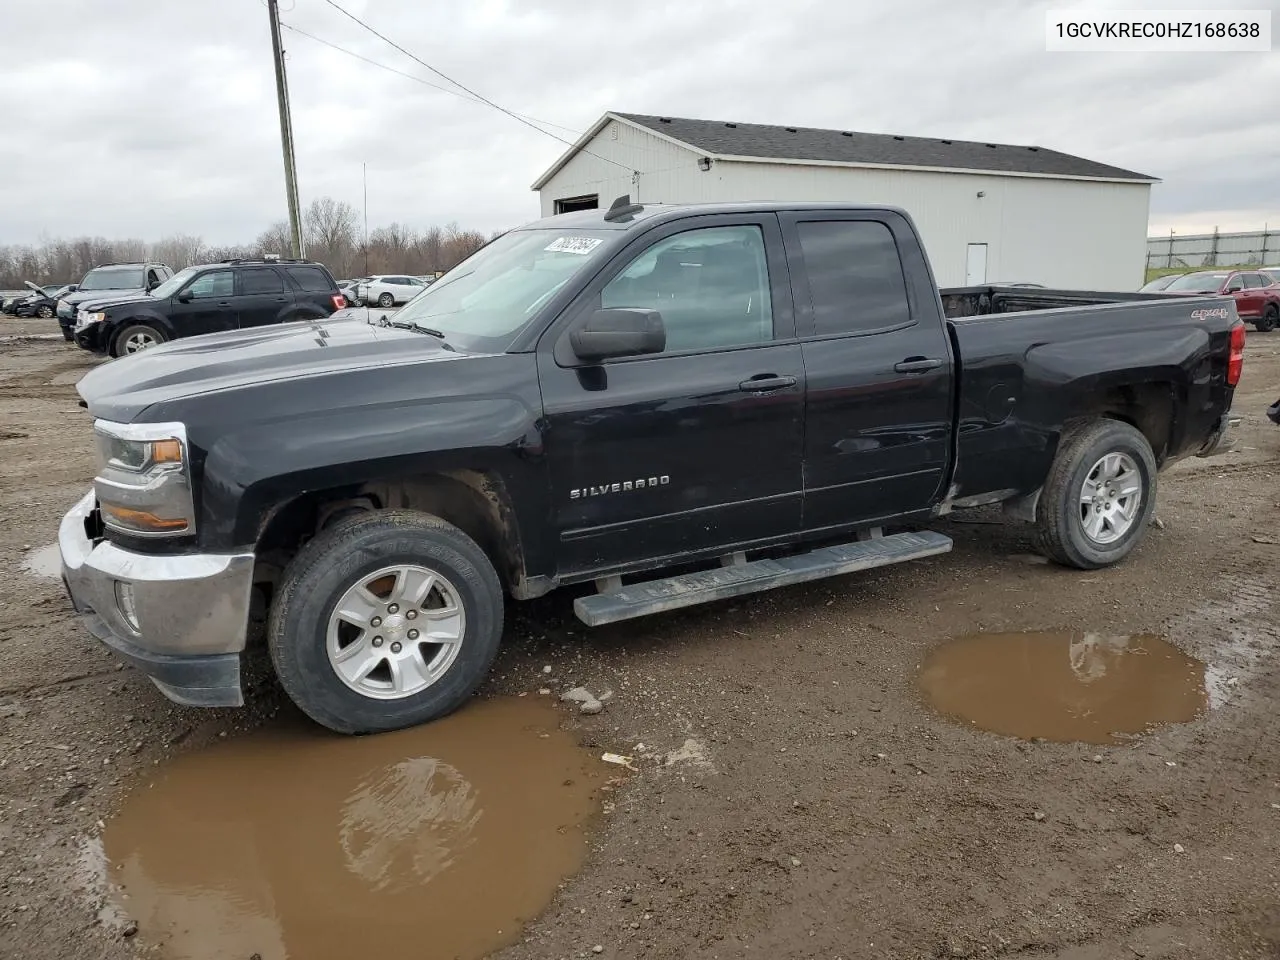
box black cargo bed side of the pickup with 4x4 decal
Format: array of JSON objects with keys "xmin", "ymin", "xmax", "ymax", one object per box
[{"xmin": 940, "ymin": 287, "xmax": 1236, "ymax": 506}]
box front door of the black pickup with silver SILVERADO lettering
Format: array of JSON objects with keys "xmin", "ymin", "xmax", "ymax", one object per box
[{"xmin": 538, "ymin": 214, "xmax": 804, "ymax": 576}]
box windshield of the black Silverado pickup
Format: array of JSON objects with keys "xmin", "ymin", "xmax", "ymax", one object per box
[{"xmin": 396, "ymin": 229, "xmax": 609, "ymax": 346}]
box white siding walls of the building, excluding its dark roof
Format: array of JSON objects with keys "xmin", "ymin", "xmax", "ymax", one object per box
[{"xmin": 540, "ymin": 128, "xmax": 1151, "ymax": 291}]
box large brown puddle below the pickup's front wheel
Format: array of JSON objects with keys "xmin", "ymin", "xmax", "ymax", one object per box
[{"xmin": 105, "ymin": 698, "xmax": 608, "ymax": 960}]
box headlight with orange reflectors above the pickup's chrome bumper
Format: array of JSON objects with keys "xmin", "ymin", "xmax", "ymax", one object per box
[{"xmin": 93, "ymin": 420, "xmax": 196, "ymax": 536}]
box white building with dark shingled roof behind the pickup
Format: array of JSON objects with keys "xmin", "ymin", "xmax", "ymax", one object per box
[{"xmin": 532, "ymin": 113, "xmax": 1158, "ymax": 289}]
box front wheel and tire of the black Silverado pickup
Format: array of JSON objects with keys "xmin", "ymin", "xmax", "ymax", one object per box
[{"xmin": 268, "ymin": 511, "xmax": 503, "ymax": 733}]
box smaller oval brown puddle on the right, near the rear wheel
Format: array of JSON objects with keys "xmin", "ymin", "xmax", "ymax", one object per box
[{"xmin": 920, "ymin": 632, "xmax": 1208, "ymax": 744}]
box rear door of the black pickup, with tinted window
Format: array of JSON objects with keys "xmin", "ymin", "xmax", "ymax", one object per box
[{"xmin": 782, "ymin": 211, "xmax": 954, "ymax": 532}]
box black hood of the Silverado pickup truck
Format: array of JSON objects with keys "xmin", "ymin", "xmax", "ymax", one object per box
[{"xmin": 77, "ymin": 317, "xmax": 468, "ymax": 422}]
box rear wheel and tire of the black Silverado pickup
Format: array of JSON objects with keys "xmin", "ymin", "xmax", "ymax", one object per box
[{"xmin": 1036, "ymin": 420, "xmax": 1157, "ymax": 570}]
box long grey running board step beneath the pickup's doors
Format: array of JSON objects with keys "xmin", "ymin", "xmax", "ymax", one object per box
[{"xmin": 573, "ymin": 530, "xmax": 951, "ymax": 627}]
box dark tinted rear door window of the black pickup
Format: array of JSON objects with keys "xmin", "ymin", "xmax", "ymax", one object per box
[{"xmin": 796, "ymin": 220, "xmax": 911, "ymax": 337}]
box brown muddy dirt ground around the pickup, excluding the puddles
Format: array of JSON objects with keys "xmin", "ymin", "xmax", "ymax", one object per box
[{"xmin": 0, "ymin": 320, "xmax": 1280, "ymax": 960}]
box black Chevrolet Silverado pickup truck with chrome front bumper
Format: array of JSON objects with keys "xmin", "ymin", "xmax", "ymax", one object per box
[{"xmin": 59, "ymin": 198, "xmax": 1244, "ymax": 732}]
